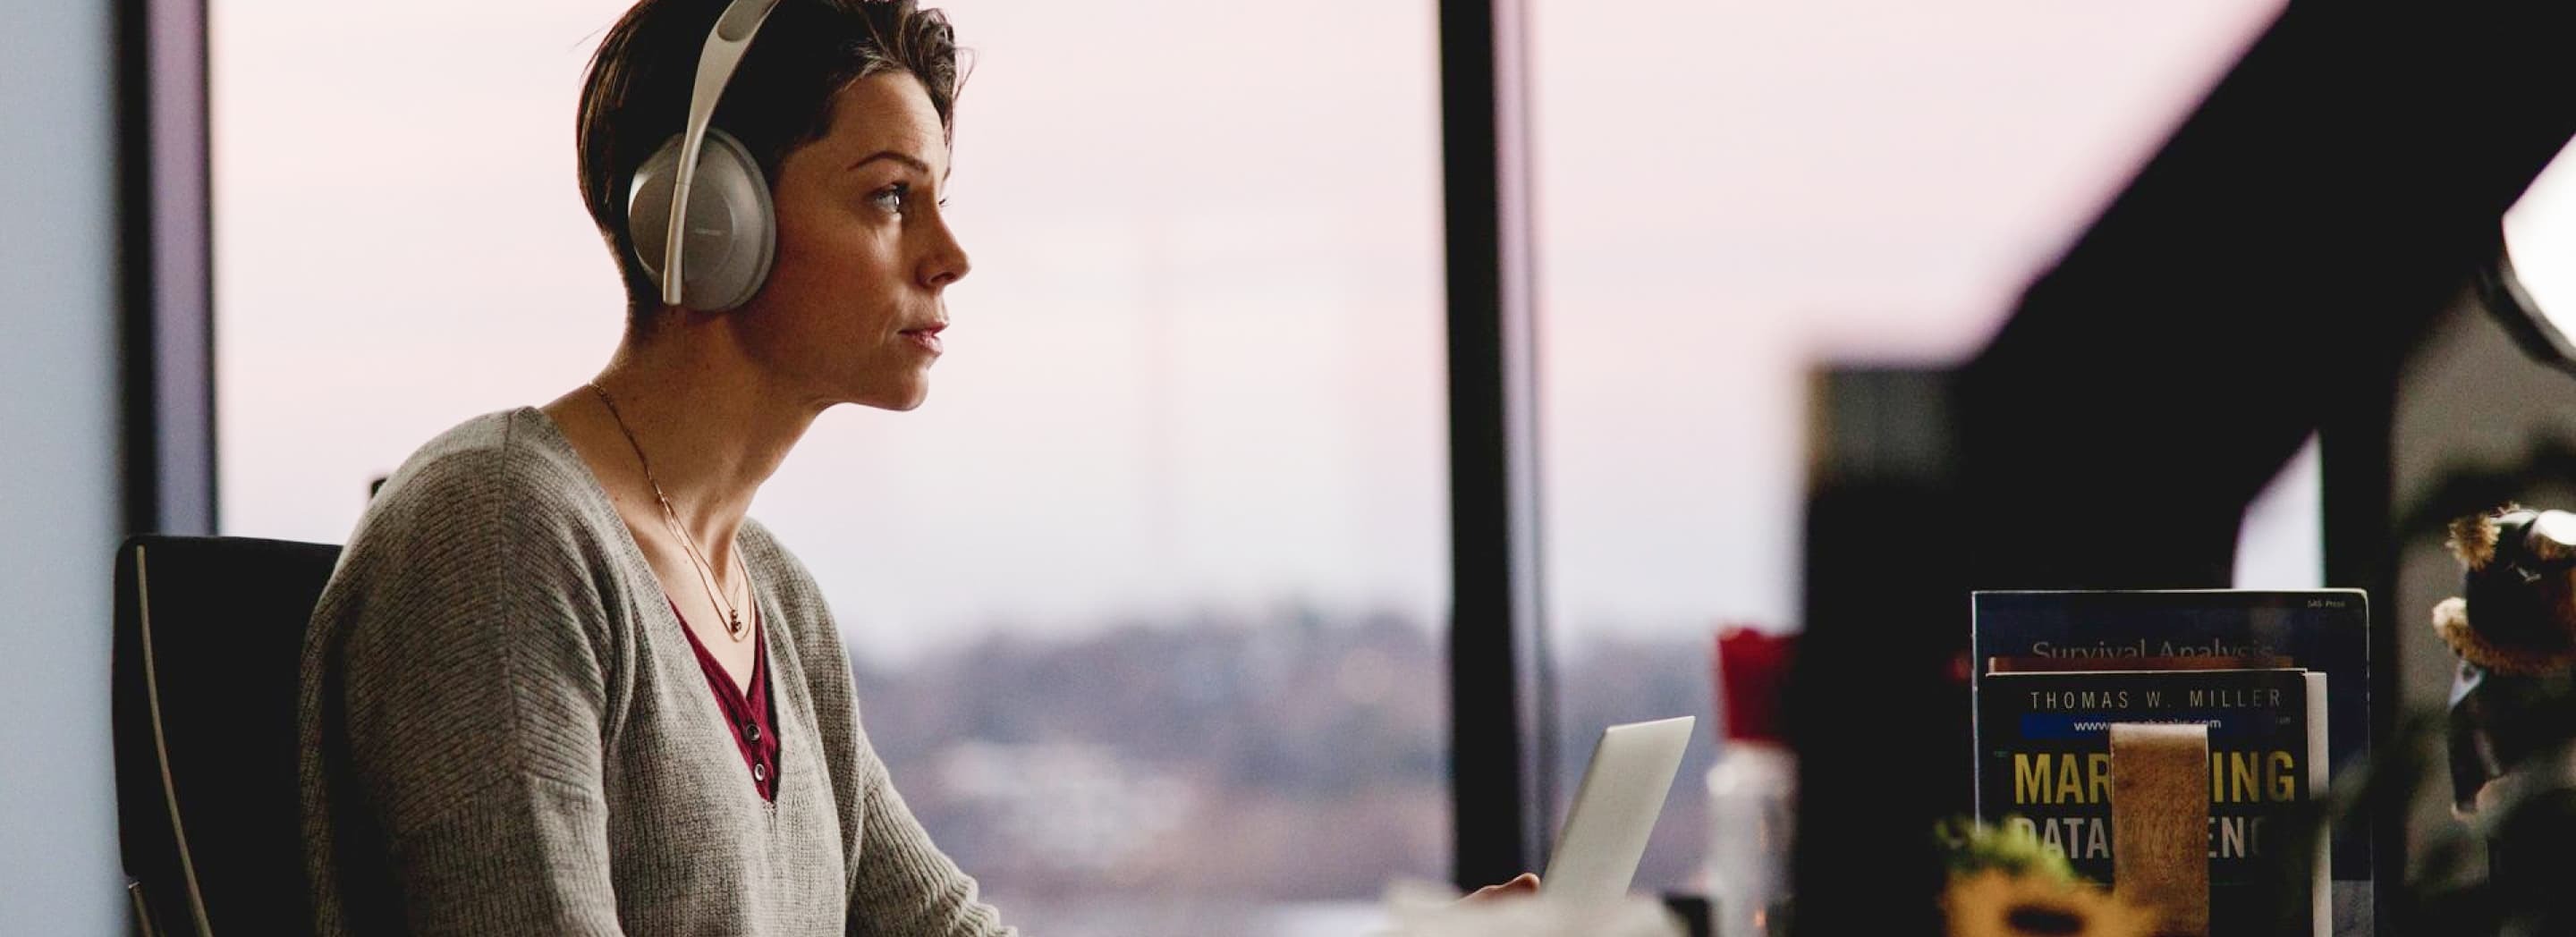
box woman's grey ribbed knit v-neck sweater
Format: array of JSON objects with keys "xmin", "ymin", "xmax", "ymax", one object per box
[{"xmin": 299, "ymin": 407, "xmax": 1015, "ymax": 937}]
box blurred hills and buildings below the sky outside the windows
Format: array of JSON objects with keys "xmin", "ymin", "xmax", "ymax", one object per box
[{"xmin": 855, "ymin": 607, "xmax": 1713, "ymax": 937}]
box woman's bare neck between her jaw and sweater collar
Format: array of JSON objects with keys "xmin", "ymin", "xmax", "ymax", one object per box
[{"xmin": 541, "ymin": 314, "xmax": 822, "ymax": 566}]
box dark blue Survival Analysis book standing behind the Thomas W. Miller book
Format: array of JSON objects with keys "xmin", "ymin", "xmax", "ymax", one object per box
[{"xmin": 1968, "ymin": 589, "xmax": 2375, "ymax": 891}]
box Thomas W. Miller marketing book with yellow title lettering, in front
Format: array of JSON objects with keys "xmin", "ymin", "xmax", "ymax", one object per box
[{"xmin": 1976, "ymin": 670, "xmax": 2331, "ymax": 937}]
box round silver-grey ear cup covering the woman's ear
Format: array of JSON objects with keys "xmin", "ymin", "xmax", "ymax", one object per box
[{"xmin": 626, "ymin": 129, "xmax": 778, "ymax": 311}]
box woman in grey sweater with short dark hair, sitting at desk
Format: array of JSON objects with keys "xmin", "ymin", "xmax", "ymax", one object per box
[{"xmin": 301, "ymin": 0, "xmax": 1010, "ymax": 934}]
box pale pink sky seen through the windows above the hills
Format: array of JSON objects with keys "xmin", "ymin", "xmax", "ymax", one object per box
[{"xmin": 211, "ymin": 0, "xmax": 2277, "ymax": 656}]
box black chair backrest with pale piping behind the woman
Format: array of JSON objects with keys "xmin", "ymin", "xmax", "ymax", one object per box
[{"xmin": 114, "ymin": 536, "xmax": 340, "ymax": 937}]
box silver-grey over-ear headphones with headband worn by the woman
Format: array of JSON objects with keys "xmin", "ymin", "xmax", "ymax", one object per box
[{"xmin": 626, "ymin": 0, "xmax": 778, "ymax": 311}]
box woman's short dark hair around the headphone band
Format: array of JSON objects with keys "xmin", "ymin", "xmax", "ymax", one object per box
[{"xmin": 574, "ymin": 0, "xmax": 966, "ymax": 322}]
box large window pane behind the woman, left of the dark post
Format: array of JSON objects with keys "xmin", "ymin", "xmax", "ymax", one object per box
[{"xmin": 211, "ymin": 0, "xmax": 1448, "ymax": 934}]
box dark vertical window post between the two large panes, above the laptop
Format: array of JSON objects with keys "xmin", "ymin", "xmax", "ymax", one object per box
[{"xmin": 1440, "ymin": 0, "xmax": 1556, "ymax": 888}]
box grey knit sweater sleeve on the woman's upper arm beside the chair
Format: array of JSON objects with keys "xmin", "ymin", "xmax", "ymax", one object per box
[{"xmin": 319, "ymin": 451, "xmax": 621, "ymax": 934}]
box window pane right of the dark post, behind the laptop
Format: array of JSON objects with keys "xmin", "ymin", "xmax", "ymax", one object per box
[{"xmin": 1530, "ymin": 0, "xmax": 2313, "ymax": 888}]
